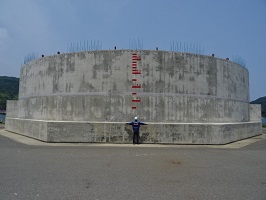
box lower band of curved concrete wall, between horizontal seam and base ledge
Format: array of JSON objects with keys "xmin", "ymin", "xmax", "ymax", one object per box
[{"xmin": 7, "ymin": 94, "xmax": 249, "ymax": 123}]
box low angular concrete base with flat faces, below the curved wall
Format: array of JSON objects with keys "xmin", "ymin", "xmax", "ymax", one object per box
[{"xmin": 5, "ymin": 117, "xmax": 262, "ymax": 144}]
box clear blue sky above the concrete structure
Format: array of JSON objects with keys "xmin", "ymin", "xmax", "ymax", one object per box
[{"xmin": 0, "ymin": 0, "xmax": 266, "ymax": 100}]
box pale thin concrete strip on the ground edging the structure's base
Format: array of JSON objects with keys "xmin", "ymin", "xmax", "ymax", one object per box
[{"xmin": 0, "ymin": 129, "xmax": 266, "ymax": 149}]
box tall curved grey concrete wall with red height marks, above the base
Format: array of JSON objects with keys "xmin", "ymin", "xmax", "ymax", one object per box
[{"xmin": 18, "ymin": 50, "xmax": 249, "ymax": 122}]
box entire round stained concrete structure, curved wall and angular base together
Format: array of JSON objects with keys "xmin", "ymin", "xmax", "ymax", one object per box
[{"xmin": 6, "ymin": 50, "xmax": 262, "ymax": 144}]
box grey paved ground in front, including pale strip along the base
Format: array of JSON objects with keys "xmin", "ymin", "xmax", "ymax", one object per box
[{"xmin": 0, "ymin": 129, "xmax": 266, "ymax": 200}]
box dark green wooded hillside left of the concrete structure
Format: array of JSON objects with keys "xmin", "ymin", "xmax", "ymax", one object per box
[{"xmin": 0, "ymin": 76, "xmax": 19, "ymax": 110}]
